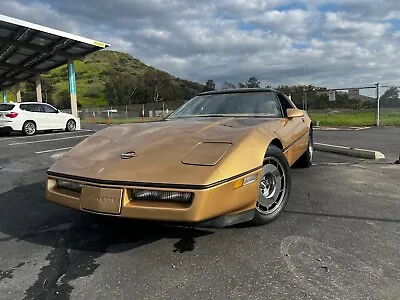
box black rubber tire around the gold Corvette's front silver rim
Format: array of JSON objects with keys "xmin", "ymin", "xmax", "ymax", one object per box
[{"xmin": 252, "ymin": 145, "xmax": 292, "ymax": 225}]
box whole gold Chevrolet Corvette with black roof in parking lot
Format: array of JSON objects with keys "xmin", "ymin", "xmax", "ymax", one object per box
[{"xmin": 46, "ymin": 89, "xmax": 313, "ymax": 227}]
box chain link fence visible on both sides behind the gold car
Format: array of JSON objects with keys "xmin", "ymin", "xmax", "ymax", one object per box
[{"xmin": 60, "ymin": 84, "xmax": 400, "ymax": 126}]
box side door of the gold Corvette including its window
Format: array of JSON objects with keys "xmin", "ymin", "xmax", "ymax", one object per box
[{"xmin": 277, "ymin": 93, "xmax": 308, "ymax": 160}]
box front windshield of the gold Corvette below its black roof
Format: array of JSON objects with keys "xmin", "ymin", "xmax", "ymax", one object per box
[{"xmin": 168, "ymin": 92, "xmax": 282, "ymax": 119}]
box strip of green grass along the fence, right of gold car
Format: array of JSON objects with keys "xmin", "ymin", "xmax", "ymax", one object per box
[{"xmin": 308, "ymin": 108, "xmax": 400, "ymax": 126}]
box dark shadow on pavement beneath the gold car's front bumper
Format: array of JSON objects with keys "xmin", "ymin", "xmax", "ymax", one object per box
[{"xmin": 0, "ymin": 183, "xmax": 213, "ymax": 253}]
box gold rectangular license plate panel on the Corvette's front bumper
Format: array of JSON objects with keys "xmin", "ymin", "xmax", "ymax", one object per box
[{"xmin": 81, "ymin": 185, "xmax": 123, "ymax": 214}]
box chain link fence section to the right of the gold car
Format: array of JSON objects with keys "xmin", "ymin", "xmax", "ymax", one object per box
[{"xmin": 289, "ymin": 84, "xmax": 400, "ymax": 126}]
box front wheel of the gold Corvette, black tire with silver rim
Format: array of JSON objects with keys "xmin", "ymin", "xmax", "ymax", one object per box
[{"xmin": 250, "ymin": 145, "xmax": 292, "ymax": 225}]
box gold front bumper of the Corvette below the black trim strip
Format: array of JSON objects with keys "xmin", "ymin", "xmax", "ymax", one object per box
[{"xmin": 46, "ymin": 170, "xmax": 261, "ymax": 227}]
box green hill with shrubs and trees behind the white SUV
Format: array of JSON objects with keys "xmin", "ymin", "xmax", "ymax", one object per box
[{"xmin": 8, "ymin": 50, "xmax": 204, "ymax": 108}]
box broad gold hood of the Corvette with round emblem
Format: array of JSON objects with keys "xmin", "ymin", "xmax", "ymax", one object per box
[{"xmin": 49, "ymin": 118, "xmax": 277, "ymax": 185}]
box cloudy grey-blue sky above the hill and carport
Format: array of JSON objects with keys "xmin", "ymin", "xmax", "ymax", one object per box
[{"xmin": 1, "ymin": 0, "xmax": 400, "ymax": 88}]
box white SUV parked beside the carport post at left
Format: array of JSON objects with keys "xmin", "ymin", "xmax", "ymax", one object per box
[{"xmin": 0, "ymin": 102, "xmax": 79, "ymax": 135}]
